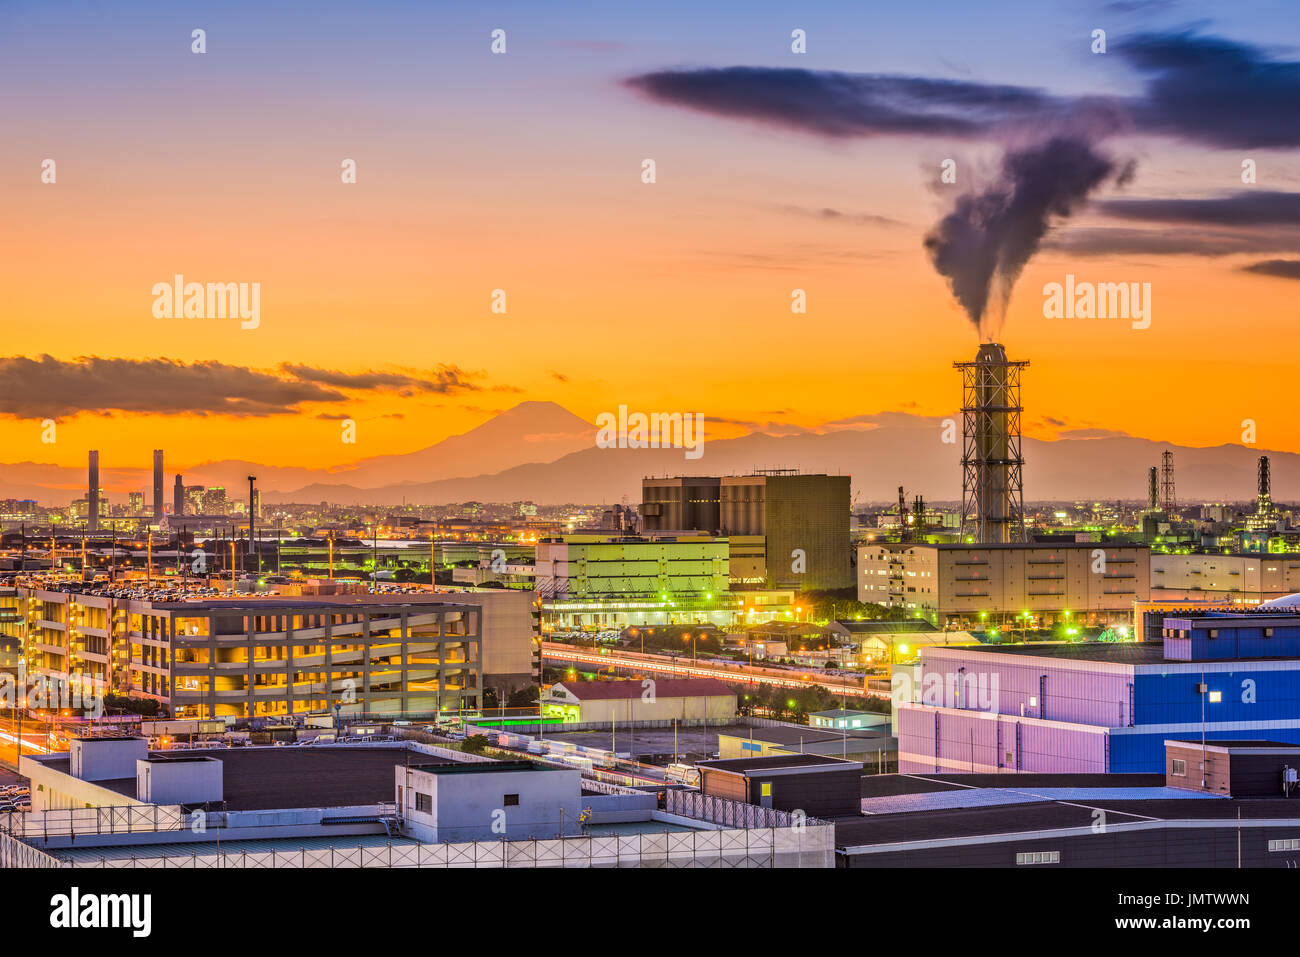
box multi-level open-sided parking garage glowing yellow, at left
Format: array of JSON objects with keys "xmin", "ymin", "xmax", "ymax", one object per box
[{"xmin": 0, "ymin": 588, "xmax": 486, "ymax": 718}]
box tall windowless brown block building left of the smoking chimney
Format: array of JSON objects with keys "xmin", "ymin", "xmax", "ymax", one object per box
[{"xmin": 641, "ymin": 469, "xmax": 853, "ymax": 589}]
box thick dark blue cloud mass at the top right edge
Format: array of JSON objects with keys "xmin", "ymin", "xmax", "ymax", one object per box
[{"xmin": 1113, "ymin": 30, "xmax": 1300, "ymax": 148}]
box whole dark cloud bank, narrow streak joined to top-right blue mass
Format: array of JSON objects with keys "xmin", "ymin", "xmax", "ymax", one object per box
[{"xmin": 624, "ymin": 30, "xmax": 1300, "ymax": 147}]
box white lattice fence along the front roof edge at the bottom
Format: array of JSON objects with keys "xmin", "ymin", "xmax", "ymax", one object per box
[{"xmin": 58, "ymin": 826, "xmax": 835, "ymax": 870}]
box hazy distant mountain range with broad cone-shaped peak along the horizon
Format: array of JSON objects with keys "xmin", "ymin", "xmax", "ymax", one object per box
[{"xmin": 0, "ymin": 402, "xmax": 1300, "ymax": 505}]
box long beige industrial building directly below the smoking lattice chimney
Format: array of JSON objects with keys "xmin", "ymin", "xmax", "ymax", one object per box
[{"xmin": 858, "ymin": 542, "xmax": 1151, "ymax": 628}]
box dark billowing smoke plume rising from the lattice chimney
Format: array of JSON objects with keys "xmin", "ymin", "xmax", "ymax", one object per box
[{"xmin": 926, "ymin": 134, "xmax": 1134, "ymax": 335}]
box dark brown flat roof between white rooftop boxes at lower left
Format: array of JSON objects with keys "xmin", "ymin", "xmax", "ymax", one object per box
[{"xmin": 42, "ymin": 745, "xmax": 465, "ymax": 811}]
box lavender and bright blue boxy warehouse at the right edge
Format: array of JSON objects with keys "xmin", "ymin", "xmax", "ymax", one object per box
[{"xmin": 897, "ymin": 612, "xmax": 1300, "ymax": 774}]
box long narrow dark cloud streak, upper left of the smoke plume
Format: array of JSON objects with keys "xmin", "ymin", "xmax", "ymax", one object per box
[{"xmin": 625, "ymin": 66, "xmax": 1066, "ymax": 138}]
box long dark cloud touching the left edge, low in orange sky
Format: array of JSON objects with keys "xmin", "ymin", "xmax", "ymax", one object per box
[{"xmin": 0, "ymin": 355, "xmax": 345, "ymax": 419}]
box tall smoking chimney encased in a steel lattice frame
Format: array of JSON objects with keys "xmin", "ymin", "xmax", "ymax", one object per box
[{"xmin": 953, "ymin": 342, "xmax": 1028, "ymax": 545}]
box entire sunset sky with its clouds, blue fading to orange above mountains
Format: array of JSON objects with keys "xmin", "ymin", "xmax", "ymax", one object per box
[{"xmin": 0, "ymin": 0, "xmax": 1300, "ymax": 471}]
